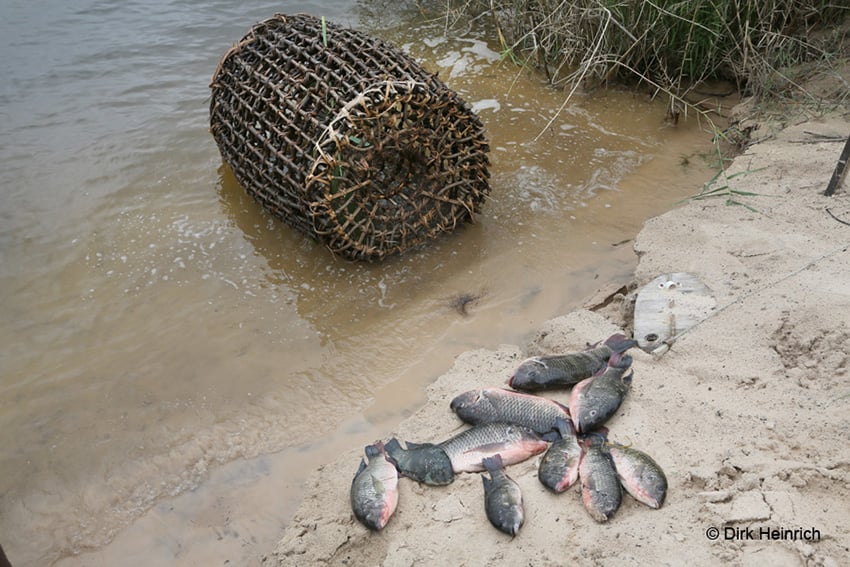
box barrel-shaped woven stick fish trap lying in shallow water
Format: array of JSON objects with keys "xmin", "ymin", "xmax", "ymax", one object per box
[{"xmin": 210, "ymin": 14, "xmax": 490, "ymax": 260}]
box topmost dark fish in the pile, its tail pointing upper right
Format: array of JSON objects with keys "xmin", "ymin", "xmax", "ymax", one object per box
[{"xmin": 508, "ymin": 333, "xmax": 637, "ymax": 391}]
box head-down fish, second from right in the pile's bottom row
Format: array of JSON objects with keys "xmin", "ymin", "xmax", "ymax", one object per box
[{"xmin": 578, "ymin": 434, "xmax": 623, "ymax": 522}]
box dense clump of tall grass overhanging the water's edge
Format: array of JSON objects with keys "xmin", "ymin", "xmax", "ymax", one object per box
[{"xmin": 449, "ymin": 0, "xmax": 850, "ymax": 102}]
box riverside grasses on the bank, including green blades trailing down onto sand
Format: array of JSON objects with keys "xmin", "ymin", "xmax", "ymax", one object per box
[{"xmin": 438, "ymin": 0, "xmax": 850, "ymax": 211}]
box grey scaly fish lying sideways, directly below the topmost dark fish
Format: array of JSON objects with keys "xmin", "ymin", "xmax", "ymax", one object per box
[{"xmin": 451, "ymin": 388, "xmax": 570, "ymax": 434}]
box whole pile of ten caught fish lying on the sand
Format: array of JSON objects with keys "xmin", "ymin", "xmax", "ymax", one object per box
[{"xmin": 351, "ymin": 334, "xmax": 667, "ymax": 535}]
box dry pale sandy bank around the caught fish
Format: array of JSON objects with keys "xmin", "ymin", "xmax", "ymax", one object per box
[{"xmin": 267, "ymin": 116, "xmax": 850, "ymax": 567}]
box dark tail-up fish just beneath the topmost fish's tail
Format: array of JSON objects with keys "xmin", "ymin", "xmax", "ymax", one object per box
[{"xmin": 569, "ymin": 353, "xmax": 634, "ymax": 433}]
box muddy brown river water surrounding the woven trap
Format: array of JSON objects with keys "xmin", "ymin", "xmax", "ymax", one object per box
[{"xmin": 0, "ymin": 0, "xmax": 728, "ymax": 566}]
